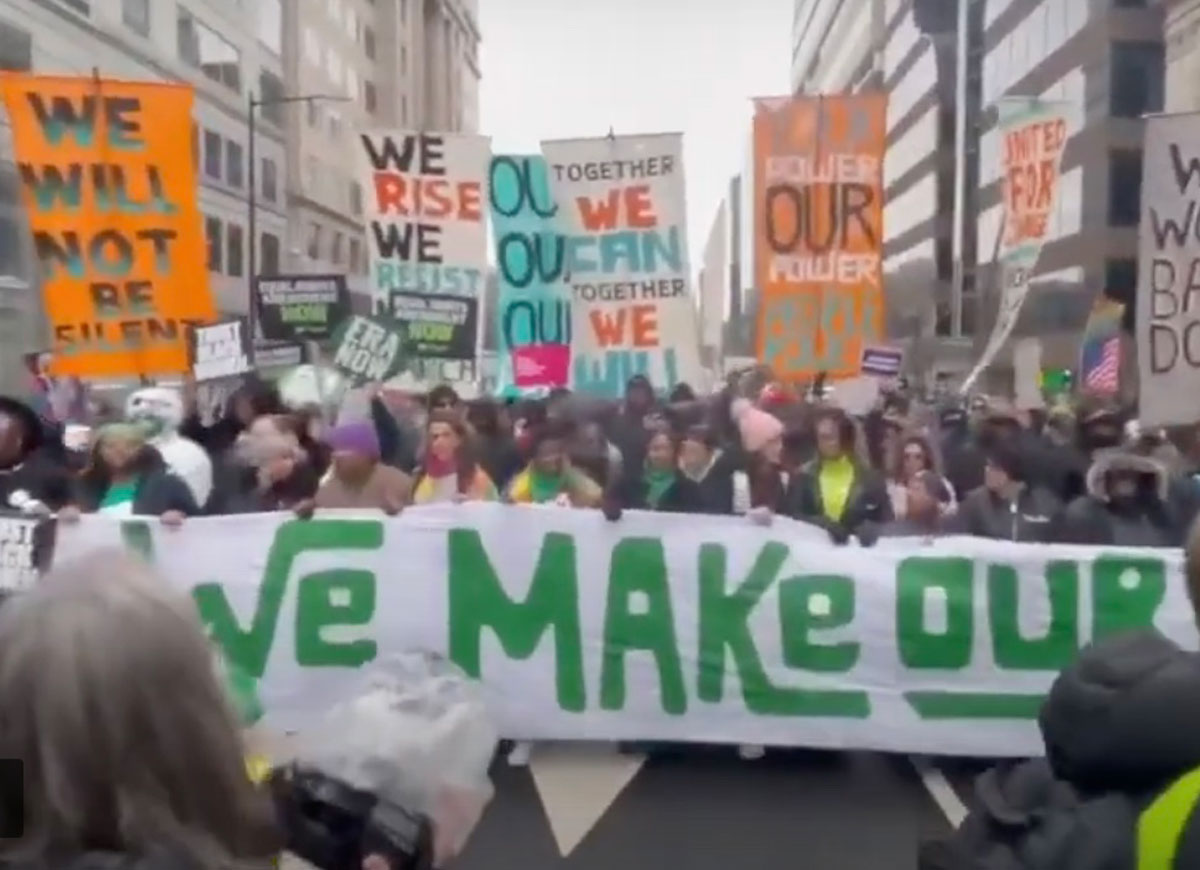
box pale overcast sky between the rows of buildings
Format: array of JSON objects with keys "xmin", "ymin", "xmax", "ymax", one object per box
[{"xmin": 479, "ymin": 0, "xmax": 793, "ymax": 254}]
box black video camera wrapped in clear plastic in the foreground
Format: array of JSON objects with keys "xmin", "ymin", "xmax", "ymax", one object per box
[{"xmin": 258, "ymin": 653, "xmax": 498, "ymax": 870}]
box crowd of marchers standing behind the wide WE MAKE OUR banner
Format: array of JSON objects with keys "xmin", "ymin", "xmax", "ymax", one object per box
[{"xmin": 0, "ymin": 371, "xmax": 1200, "ymax": 546}]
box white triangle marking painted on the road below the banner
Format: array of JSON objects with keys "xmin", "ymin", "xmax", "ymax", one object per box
[{"xmin": 529, "ymin": 744, "xmax": 646, "ymax": 858}]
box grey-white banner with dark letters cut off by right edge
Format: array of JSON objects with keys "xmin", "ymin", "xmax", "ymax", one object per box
[{"xmin": 1136, "ymin": 114, "xmax": 1200, "ymax": 426}]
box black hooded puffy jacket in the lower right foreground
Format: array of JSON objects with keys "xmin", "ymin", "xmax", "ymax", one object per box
[{"xmin": 919, "ymin": 631, "xmax": 1200, "ymax": 870}]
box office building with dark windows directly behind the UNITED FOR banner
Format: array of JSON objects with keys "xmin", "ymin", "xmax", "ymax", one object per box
[{"xmin": 977, "ymin": 0, "xmax": 1165, "ymax": 366}]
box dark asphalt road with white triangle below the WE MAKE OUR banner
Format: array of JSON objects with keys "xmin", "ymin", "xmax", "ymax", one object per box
[{"xmin": 452, "ymin": 746, "xmax": 978, "ymax": 870}]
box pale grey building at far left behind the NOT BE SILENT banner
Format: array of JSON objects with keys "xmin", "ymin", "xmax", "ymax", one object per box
[{"xmin": 0, "ymin": 0, "xmax": 287, "ymax": 389}]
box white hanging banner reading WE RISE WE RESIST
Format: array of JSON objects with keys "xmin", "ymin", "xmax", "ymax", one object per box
[{"xmin": 358, "ymin": 130, "xmax": 491, "ymax": 359}]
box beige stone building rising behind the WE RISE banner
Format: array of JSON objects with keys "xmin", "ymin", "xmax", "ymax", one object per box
[{"xmin": 283, "ymin": 0, "xmax": 480, "ymax": 302}]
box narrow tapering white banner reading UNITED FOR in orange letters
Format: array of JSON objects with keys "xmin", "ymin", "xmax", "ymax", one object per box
[{"xmin": 961, "ymin": 97, "xmax": 1072, "ymax": 392}]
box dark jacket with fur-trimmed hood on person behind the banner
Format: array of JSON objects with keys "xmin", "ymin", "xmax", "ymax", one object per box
[{"xmin": 1058, "ymin": 450, "xmax": 1186, "ymax": 547}]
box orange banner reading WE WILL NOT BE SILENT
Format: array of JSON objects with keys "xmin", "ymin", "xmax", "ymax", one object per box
[{"xmin": 0, "ymin": 73, "xmax": 216, "ymax": 377}]
